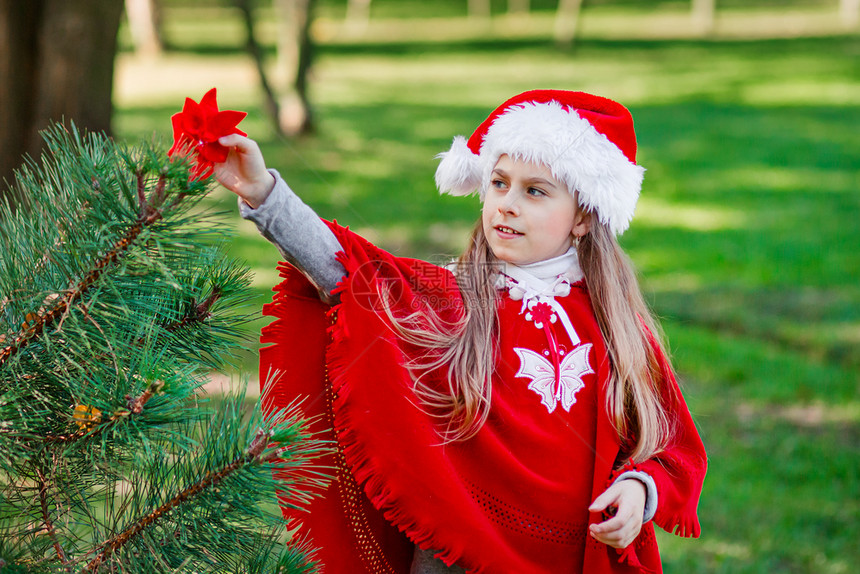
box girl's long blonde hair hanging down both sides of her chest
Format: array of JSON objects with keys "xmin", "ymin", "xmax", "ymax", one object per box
[{"xmin": 383, "ymin": 217, "xmax": 674, "ymax": 462}]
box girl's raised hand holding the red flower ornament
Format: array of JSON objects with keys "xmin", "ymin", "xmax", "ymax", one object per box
[{"xmin": 215, "ymin": 134, "xmax": 275, "ymax": 209}]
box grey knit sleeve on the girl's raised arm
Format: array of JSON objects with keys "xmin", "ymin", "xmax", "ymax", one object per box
[{"xmin": 239, "ymin": 169, "xmax": 346, "ymax": 302}]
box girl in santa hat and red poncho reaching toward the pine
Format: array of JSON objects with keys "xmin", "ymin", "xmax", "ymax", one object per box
[{"xmin": 215, "ymin": 90, "xmax": 706, "ymax": 574}]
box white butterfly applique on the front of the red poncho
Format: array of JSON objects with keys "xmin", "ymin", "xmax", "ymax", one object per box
[{"xmin": 514, "ymin": 343, "xmax": 594, "ymax": 413}]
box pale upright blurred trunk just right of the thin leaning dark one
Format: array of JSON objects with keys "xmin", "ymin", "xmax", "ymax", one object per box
[{"xmin": 275, "ymin": 0, "xmax": 314, "ymax": 135}]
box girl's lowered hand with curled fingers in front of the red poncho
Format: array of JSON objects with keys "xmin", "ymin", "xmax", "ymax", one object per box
[{"xmin": 588, "ymin": 479, "xmax": 647, "ymax": 548}]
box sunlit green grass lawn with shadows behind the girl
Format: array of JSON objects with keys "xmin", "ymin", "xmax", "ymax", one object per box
[{"xmin": 116, "ymin": 6, "xmax": 860, "ymax": 574}]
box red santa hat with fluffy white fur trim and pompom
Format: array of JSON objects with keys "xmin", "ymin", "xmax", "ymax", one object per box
[{"xmin": 436, "ymin": 90, "xmax": 645, "ymax": 235}]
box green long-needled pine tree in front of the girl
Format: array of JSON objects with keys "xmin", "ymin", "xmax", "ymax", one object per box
[{"xmin": 0, "ymin": 125, "xmax": 325, "ymax": 574}]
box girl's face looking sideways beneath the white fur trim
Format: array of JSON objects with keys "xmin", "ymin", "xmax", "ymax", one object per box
[{"xmin": 481, "ymin": 155, "xmax": 590, "ymax": 265}]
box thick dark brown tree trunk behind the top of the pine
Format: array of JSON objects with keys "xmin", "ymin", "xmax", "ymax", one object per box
[{"xmin": 0, "ymin": 0, "xmax": 123, "ymax": 206}]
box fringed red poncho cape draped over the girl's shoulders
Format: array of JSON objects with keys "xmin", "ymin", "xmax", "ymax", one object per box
[{"xmin": 260, "ymin": 225, "xmax": 706, "ymax": 574}]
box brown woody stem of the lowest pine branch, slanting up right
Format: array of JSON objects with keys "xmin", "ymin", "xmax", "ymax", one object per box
[{"xmin": 81, "ymin": 429, "xmax": 278, "ymax": 572}]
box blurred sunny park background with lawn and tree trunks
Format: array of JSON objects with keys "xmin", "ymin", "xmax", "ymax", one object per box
[{"xmin": 0, "ymin": 0, "xmax": 860, "ymax": 573}]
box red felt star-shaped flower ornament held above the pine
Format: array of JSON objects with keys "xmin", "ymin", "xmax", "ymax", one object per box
[{"xmin": 167, "ymin": 88, "xmax": 248, "ymax": 179}]
